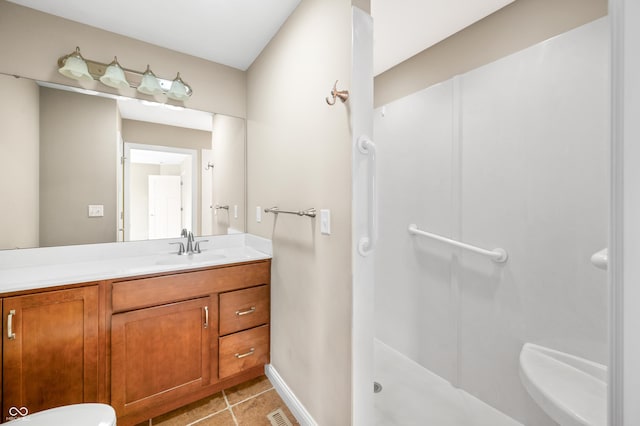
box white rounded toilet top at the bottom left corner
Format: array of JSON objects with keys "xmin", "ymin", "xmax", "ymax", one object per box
[{"xmin": 5, "ymin": 403, "xmax": 116, "ymax": 426}]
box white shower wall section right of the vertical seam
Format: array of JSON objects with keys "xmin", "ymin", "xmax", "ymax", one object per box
[{"xmin": 459, "ymin": 19, "xmax": 609, "ymax": 424}]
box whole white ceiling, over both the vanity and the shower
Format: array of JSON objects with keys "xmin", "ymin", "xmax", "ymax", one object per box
[{"xmin": 9, "ymin": 0, "xmax": 514, "ymax": 75}]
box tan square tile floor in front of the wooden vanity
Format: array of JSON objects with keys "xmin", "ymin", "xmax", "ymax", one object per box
[{"xmin": 137, "ymin": 376, "xmax": 299, "ymax": 426}]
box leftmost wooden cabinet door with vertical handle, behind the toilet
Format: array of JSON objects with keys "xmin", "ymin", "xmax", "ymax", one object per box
[{"xmin": 2, "ymin": 286, "xmax": 98, "ymax": 420}]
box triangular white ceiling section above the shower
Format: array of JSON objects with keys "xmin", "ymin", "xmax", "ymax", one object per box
[{"xmin": 371, "ymin": 0, "xmax": 514, "ymax": 75}]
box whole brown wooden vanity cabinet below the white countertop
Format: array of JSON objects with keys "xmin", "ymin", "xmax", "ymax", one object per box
[{"xmin": 0, "ymin": 260, "xmax": 271, "ymax": 426}]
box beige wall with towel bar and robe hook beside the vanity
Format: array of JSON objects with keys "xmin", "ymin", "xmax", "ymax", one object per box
[{"xmin": 247, "ymin": 0, "xmax": 351, "ymax": 425}]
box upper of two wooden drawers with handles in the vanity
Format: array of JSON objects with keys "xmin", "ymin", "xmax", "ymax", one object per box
[{"xmin": 220, "ymin": 285, "xmax": 269, "ymax": 336}]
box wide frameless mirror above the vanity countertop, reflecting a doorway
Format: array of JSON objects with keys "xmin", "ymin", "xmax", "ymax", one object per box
[{"xmin": 0, "ymin": 74, "xmax": 246, "ymax": 249}]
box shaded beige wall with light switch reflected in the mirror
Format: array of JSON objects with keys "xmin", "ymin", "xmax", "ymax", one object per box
[{"xmin": 40, "ymin": 87, "xmax": 118, "ymax": 247}]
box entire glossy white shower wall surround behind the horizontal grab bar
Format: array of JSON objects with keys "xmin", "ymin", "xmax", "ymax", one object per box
[{"xmin": 374, "ymin": 18, "xmax": 609, "ymax": 426}]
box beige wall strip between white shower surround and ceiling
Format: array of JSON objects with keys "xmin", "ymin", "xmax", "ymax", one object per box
[{"xmin": 374, "ymin": 0, "xmax": 607, "ymax": 107}]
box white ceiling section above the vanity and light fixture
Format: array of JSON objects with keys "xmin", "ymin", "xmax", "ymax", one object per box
[{"xmin": 9, "ymin": 0, "xmax": 300, "ymax": 70}]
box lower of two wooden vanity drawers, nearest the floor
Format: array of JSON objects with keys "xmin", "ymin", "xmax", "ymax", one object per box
[{"xmin": 219, "ymin": 325, "xmax": 269, "ymax": 379}]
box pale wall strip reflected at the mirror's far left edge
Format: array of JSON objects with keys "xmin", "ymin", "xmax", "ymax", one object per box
[{"xmin": 0, "ymin": 75, "xmax": 40, "ymax": 249}]
